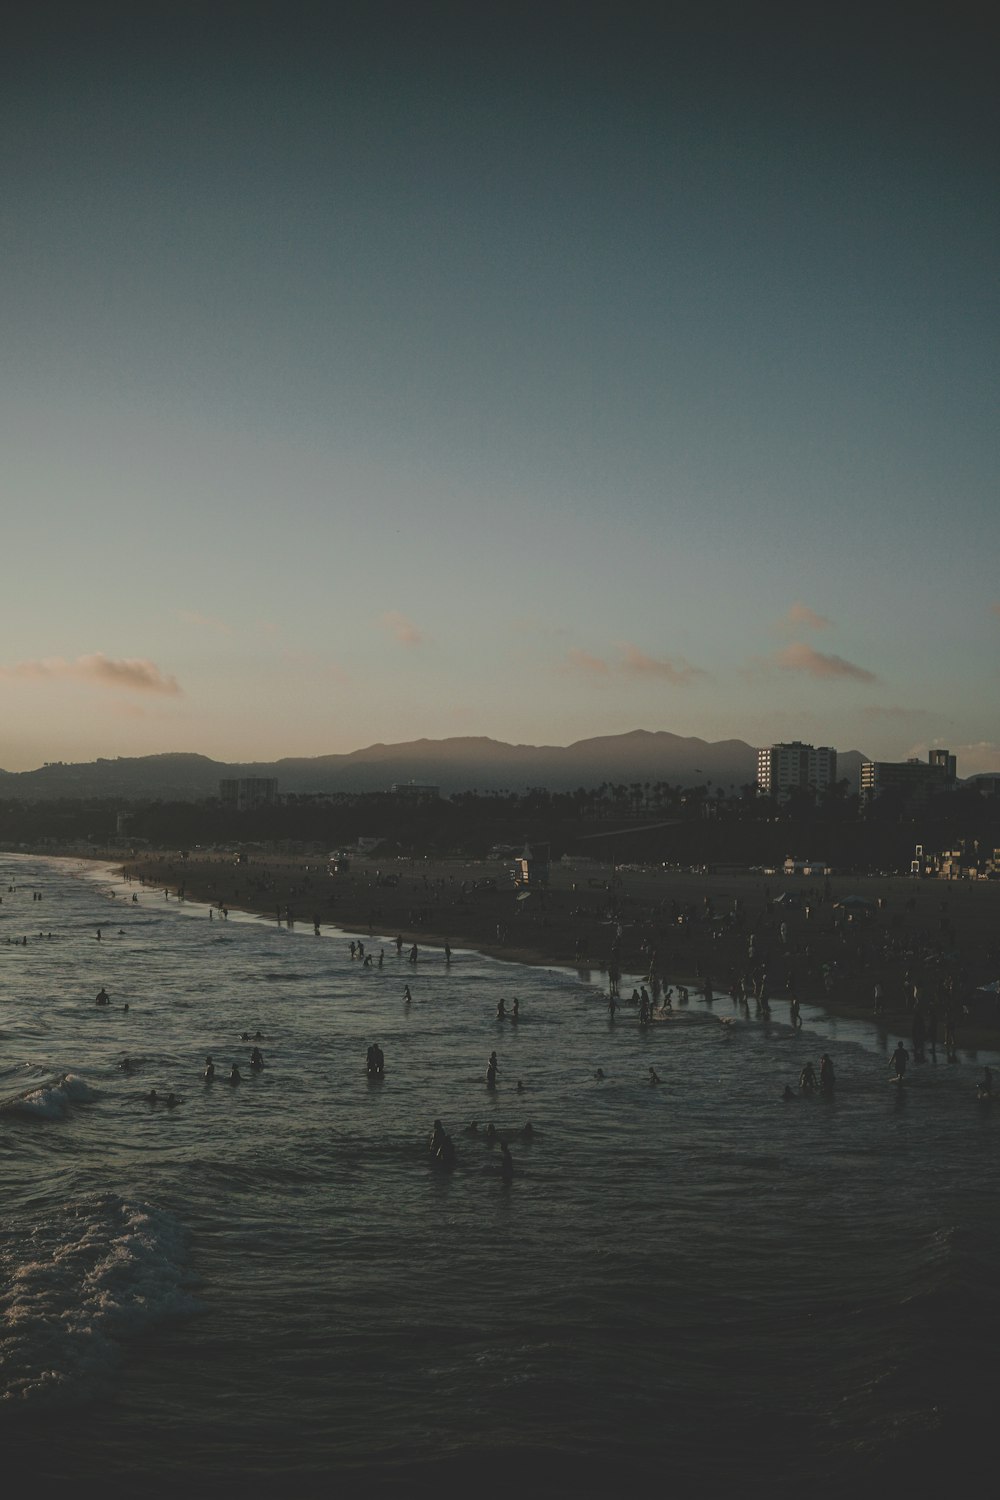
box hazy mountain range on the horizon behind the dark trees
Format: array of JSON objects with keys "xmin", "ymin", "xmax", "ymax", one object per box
[{"xmin": 0, "ymin": 729, "xmax": 865, "ymax": 801}]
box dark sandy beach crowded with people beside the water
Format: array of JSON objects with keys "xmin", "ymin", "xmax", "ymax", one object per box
[{"xmin": 124, "ymin": 852, "xmax": 1000, "ymax": 1049}]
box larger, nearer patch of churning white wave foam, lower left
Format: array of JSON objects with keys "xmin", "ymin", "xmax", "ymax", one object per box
[{"xmin": 0, "ymin": 1196, "xmax": 195, "ymax": 1403}]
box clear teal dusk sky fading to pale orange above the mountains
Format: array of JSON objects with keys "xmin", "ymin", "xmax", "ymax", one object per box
[{"xmin": 0, "ymin": 0, "xmax": 1000, "ymax": 776}]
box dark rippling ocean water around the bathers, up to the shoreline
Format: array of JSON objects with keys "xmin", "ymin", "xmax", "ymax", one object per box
[{"xmin": 0, "ymin": 857, "xmax": 1000, "ymax": 1496}]
